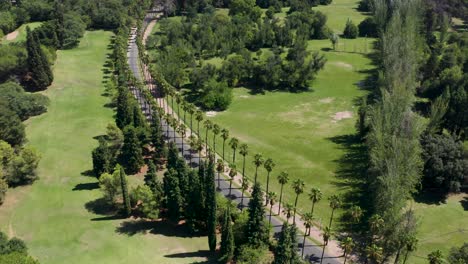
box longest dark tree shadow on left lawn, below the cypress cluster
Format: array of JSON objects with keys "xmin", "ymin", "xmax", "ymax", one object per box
[{"xmin": 115, "ymin": 219, "xmax": 205, "ymax": 238}]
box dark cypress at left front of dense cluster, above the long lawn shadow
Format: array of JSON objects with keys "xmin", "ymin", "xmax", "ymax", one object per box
[{"xmin": 164, "ymin": 169, "xmax": 182, "ymax": 222}]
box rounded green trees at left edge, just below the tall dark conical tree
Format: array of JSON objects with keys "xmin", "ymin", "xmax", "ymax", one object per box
[{"xmin": 0, "ymin": 82, "xmax": 49, "ymax": 120}]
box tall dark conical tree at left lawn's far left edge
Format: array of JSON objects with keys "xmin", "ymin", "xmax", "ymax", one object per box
[{"xmin": 26, "ymin": 27, "xmax": 52, "ymax": 91}]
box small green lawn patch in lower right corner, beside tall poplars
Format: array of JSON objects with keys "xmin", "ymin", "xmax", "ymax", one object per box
[{"xmin": 408, "ymin": 194, "xmax": 468, "ymax": 264}]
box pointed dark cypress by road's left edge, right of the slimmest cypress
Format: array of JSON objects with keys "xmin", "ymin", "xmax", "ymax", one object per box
[{"xmin": 246, "ymin": 182, "xmax": 268, "ymax": 247}]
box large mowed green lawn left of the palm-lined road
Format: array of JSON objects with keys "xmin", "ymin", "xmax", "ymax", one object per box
[{"xmin": 0, "ymin": 31, "xmax": 208, "ymax": 264}]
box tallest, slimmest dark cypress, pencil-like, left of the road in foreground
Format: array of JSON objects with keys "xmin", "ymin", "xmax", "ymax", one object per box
[{"xmin": 205, "ymin": 159, "xmax": 216, "ymax": 251}]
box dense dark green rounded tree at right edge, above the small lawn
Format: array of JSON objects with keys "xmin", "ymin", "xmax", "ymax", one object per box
[{"xmin": 421, "ymin": 135, "xmax": 468, "ymax": 193}]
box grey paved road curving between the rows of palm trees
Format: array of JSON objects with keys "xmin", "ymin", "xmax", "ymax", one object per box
[{"xmin": 128, "ymin": 16, "xmax": 341, "ymax": 264}]
